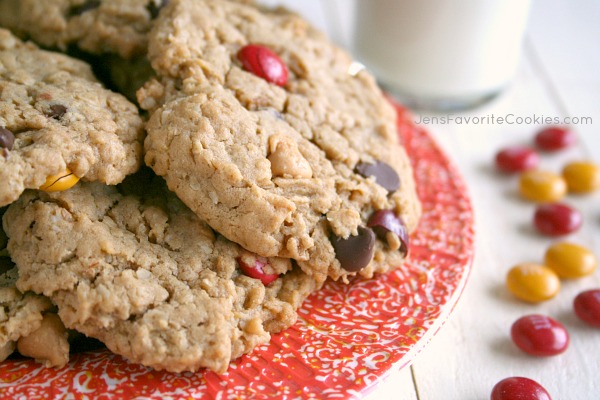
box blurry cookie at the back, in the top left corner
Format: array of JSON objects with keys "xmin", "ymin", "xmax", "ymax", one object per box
[{"xmin": 0, "ymin": 0, "xmax": 166, "ymax": 58}]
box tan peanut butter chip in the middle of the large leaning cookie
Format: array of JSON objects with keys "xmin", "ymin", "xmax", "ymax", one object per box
[{"xmin": 268, "ymin": 135, "xmax": 312, "ymax": 178}]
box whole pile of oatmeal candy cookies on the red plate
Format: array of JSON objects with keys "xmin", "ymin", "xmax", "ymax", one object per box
[{"xmin": 0, "ymin": 0, "xmax": 420, "ymax": 372}]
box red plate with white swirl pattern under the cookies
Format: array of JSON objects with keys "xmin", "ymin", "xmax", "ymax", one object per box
[{"xmin": 0, "ymin": 101, "xmax": 474, "ymax": 400}]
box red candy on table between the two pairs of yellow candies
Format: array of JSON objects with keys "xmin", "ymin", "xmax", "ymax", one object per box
[{"xmin": 533, "ymin": 203, "xmax": 583, "ymax": 236}]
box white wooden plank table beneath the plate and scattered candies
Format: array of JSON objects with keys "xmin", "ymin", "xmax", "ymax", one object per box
[{"xmin": 265, "ymin": 0, "xmax": 600, "ymax": 400}]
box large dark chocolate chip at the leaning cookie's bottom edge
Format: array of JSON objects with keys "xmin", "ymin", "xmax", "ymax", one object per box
[{"xmin": 330, "ymin": 226, "xmax": 375, "ymax": 272}]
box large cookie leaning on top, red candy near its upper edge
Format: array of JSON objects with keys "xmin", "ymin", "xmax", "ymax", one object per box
[{"xmin": 138, "ymin": 0, "xmax": 421, "ymax": 280}]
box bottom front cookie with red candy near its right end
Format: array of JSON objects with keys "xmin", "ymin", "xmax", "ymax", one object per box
[{"xmin": 4, "ymin": 174, "xmax": 318, "ymax": 372}]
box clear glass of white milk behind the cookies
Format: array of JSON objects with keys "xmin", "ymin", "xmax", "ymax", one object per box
[{"xmin": 353, "ymin": 0, "xmax": 530, "ymax": 110}]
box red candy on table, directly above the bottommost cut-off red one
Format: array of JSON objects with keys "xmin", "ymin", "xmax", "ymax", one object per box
[{"xmin": 510, "ymin": 314, "xmax": 569, "ymax": 357}]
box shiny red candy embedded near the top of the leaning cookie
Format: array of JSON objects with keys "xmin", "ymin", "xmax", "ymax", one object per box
[{"xmin": 237, "ymin": 44, "xmax": 288, "ymax": 86}]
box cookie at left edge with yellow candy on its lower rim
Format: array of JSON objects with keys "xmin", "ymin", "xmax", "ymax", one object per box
[{"xmin": 0, "ymin": 29, "xmax": 144, "ymax": 206}]
